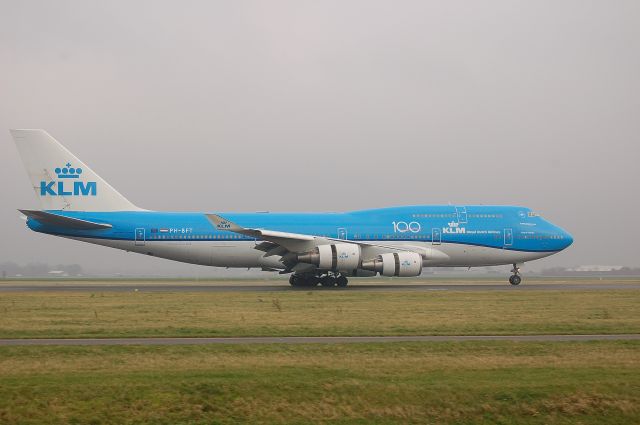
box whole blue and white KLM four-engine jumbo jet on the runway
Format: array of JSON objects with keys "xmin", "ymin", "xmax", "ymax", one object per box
[{"xmin": 11, "ymin": 129, "xmax": 573, "ymax": 287}]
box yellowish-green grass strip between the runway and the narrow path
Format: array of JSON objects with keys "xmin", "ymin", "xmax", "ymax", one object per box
[{"xmin": 0, "ymin": 288, "xmax": 640, "ymax": 338}]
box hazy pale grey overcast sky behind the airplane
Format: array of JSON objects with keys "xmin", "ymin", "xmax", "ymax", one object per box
[{"xmin": 0, "ymin": 0, "xmax": 640, "ymax": 271}]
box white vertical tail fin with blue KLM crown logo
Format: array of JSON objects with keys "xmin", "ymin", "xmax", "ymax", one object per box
[{"xmin": 11, "ymin": 130, "xmax": 140, "ymax": 211}]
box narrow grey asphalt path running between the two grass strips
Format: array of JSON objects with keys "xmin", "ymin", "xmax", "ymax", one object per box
[{"xmin": 0, "ymin": 334, "xmax": 640, "ymax": 346}]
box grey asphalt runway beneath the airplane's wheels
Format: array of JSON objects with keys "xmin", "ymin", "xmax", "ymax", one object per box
[{"xmin": 0, "ymin": 281, "xmax": 640, "ymax": 292}]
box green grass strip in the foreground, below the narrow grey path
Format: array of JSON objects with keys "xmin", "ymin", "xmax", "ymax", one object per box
[{"xmin": 0, "ymin": 341, "xmax": 640, "ymax": 424}]
